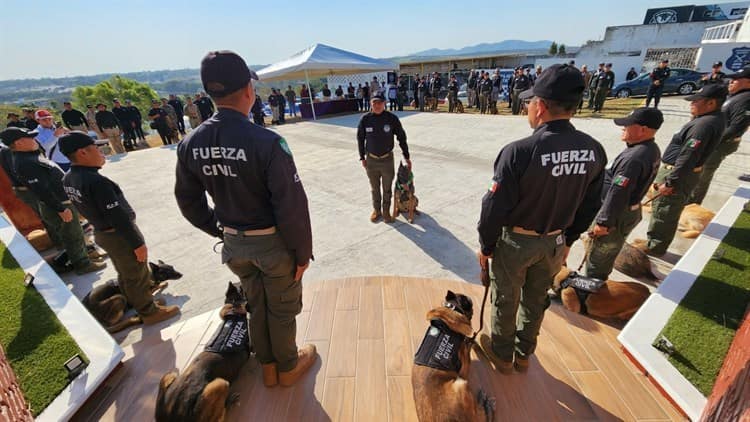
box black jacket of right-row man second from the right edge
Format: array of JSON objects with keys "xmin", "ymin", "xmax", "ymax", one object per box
[{"xmin": 661, "ymin": 110, "xmax": 726, "ymax": 188}]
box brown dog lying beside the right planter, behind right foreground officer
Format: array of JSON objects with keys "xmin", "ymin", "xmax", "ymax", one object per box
[{"xmin": 552, "ymin": 267, "xmax": 651, "ymax": 321}]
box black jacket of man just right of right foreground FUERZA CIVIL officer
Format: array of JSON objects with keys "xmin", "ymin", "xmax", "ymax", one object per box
[{"xmin": 596, "ymin": 139, "xmax": 661, "ymax": 227}]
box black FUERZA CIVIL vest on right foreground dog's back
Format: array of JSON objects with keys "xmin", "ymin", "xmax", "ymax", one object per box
[{"xmin": 414, "ymin": 318, "xmax": 466, "ymax": 372}]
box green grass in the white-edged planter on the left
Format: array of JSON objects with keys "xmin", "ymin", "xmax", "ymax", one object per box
[{"xmin": 0, "ymin": 243, "xmax": 88, "ymax": 416}]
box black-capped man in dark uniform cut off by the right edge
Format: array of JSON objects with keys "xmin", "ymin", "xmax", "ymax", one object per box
[{"xmin": 690, "ymin": 66, "xmax": 750, "ymax": 204}]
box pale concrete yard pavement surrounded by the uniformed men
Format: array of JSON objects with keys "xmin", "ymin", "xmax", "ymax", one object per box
[{"xmin": 60, "ymin": 98, "xmax": 750, "ymax": 344}]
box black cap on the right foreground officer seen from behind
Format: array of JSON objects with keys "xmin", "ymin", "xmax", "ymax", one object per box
[{"xmin": 519, "ymin": 64, "xmax": 584, "ymax": 102}]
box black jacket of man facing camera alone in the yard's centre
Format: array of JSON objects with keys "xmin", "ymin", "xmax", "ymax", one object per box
[{"xmin": 357, "ymin": 111, "xmax": 409, "ymax": 160}]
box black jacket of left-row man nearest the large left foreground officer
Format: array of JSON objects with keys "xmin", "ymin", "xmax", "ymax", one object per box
[{"xmin": 63, "ymin": 164, "xmax": 146, "ymax": 249}]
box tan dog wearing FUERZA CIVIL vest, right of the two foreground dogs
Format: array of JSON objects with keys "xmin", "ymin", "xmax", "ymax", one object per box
[{"xmin": 411, "ymin": 290, "xmax": 495, "ymax": 422}]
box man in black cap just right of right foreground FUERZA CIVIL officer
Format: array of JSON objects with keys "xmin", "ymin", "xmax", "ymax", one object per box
[{"xmin": 586, "ymin": 107, "xmax": 664, "ymax": 280}]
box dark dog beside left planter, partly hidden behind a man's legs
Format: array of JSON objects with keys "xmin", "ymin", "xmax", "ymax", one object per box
[{"xmin": 82, "ymin": 260, "xmax": 182, "ymax": 333}]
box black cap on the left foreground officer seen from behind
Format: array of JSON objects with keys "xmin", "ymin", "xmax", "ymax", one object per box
[{"xmin": 201, "ymin": 50, "xmax": 258, "ymax": 97}]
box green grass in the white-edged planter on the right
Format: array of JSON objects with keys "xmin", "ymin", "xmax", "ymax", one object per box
[{"xmin": 661, "ymin": 212, "xmax": 750, "ymax": 396}]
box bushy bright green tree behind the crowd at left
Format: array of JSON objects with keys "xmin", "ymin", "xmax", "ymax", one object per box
[{"xmin": 73, "ymin": 75, "xmax": 159, "ymax": 120}]
